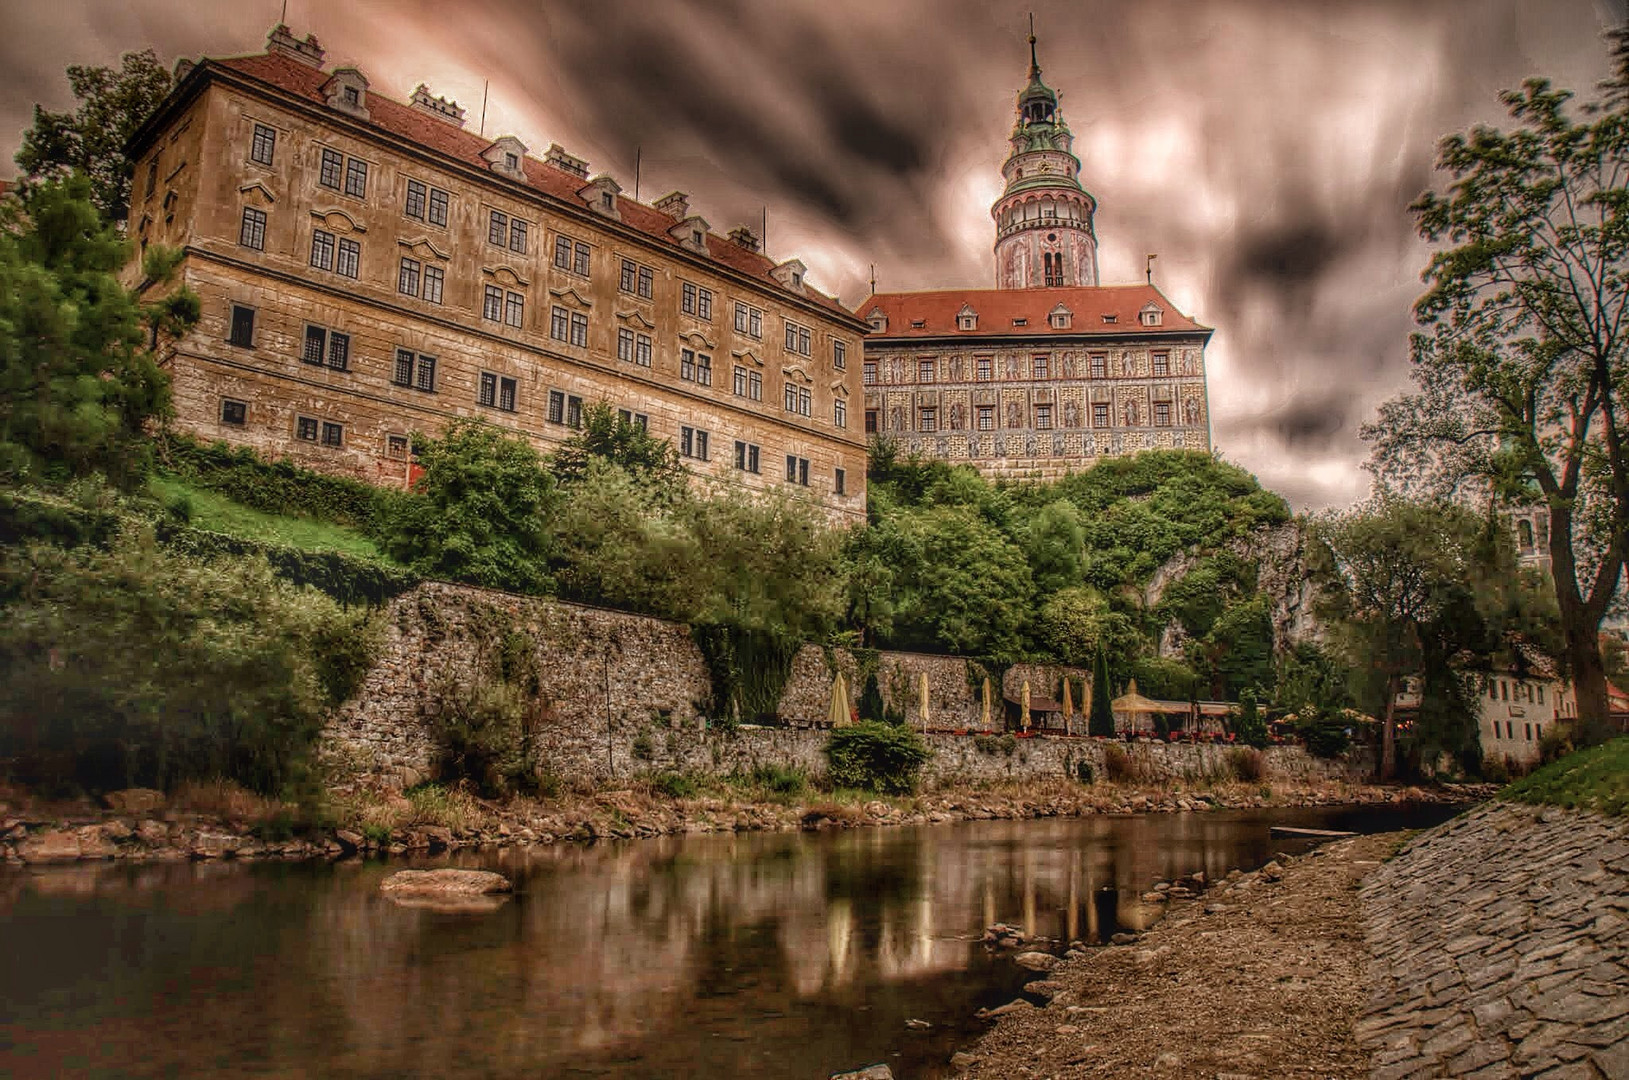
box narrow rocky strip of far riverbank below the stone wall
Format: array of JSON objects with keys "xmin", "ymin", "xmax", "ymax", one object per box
[{"xmin": 0, "ymin": 779, "xmax": 1487, "ymax": 863}]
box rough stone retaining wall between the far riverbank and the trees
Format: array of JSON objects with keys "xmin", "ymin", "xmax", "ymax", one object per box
[{"xmin": 324, "ymin": 583, "xmax": 1372, "ymax": 785}]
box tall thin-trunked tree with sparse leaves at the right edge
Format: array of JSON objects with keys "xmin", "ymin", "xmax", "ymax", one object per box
[{"xmin": 1365, "ymin": 44, "xmax": 1629, "ymax": 752}]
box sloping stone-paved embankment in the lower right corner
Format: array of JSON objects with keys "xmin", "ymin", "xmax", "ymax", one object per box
[{"xmin": 1354, "ymin": 803, "xmax": 1629, "ymax": 1080}]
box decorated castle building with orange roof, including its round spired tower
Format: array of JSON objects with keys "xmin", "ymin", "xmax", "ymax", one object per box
[{"xmin": 857, "ymin": 34, "xmax": 1212, "ymax": 479}]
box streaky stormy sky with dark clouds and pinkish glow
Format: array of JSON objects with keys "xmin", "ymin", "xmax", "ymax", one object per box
[{"xmin": 0, "ymin": 0, "xmax": 1622, "ymax": 508}]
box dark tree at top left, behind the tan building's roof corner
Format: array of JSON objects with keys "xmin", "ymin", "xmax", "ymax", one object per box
[{"xmin": 16, "ymin": 49, "xmax": 169, "ymax": 226}]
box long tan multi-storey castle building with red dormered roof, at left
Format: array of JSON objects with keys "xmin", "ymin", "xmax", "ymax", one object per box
[{"xmin": 129, "ymin": 26, "xmax": 865, "ymax": 520}]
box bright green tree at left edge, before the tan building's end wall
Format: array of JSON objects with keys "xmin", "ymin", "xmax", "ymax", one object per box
[{"xmin": 0, "ymin": 176, "xmax": 199, "ymax": 487}]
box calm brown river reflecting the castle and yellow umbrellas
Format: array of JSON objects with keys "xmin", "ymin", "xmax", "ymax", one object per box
[{"xmin": 0, "ymin": 806, "xmax": 1453, "ymax": 1080}]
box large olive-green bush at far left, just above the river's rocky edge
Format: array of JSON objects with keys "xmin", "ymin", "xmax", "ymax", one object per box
[{"xmin": 0, "ymin": 531, "xmax": 371, "ymax": 795}]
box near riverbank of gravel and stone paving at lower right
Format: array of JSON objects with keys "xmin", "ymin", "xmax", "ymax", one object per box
[{"xmin": 955, "ymin": 801, "xmax": 1629, "ymax": 1080}]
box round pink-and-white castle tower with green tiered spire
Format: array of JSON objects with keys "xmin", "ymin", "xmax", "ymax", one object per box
[{"xmin": 990, "ymin": 20, "xmax": 1098, "ymax": 288}]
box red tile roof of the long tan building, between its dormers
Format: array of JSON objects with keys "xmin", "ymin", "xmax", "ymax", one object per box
[{"xmin": 209, "ymin": 52, "xmax": 849, "ymax": 316}]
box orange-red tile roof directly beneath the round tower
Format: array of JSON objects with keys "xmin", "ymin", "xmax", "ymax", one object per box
[{"xmin": 854, "ymin": 285, "xmax": 1210, "ymax": 337}]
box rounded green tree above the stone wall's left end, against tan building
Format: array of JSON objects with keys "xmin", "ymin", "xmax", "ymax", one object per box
[{"xmin": 384, "ymin": 420, "xmax": 555, "ymax": 593}]
